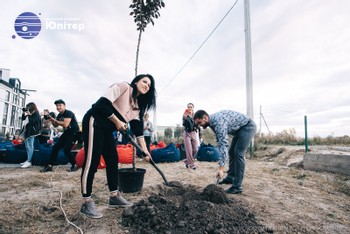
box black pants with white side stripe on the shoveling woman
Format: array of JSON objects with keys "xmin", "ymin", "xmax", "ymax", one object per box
[{"xmin": 81, "ymin": 112, "xmax": 118, "ymax": 197}]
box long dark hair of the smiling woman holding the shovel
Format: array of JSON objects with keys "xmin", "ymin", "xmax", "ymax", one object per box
[{"xmin": 131, "ymin": 74, "xmax": 157, "ymax": 120}]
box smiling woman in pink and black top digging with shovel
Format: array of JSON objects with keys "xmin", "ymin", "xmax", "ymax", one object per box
[{"xmin": 80, "ymin": 74, "xmax": 156, "ymax": 219}]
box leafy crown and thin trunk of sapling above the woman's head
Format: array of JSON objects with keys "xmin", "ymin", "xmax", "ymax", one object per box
[{"xmin": 129, "ymin": 0, "xmax": 165, "ymax": 76}]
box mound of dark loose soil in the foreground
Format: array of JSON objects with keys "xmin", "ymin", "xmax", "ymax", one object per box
[{"xmin": 122, "ymin": 184, "xmax": 273, "ymax": 234}]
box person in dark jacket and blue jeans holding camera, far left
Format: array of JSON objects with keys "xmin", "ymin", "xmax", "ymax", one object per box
[{"xmin": 21, "ymin": 102, "xmax": 41, "ymax": 168}]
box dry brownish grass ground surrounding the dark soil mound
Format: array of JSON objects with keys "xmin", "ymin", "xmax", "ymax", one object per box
[{"xmin": 0, "ymin": 147, "xmax": 350, "ymax": 234}]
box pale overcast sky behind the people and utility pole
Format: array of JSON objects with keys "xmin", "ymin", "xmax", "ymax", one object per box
[{"xmin": 0, "ymin": 0, "xmax": 350, "ymax": 136}]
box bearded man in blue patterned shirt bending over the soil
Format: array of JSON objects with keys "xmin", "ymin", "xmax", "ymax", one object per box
[{"xmin": 193, "ymin": 110, "xmax": 256, "ymax": 194}]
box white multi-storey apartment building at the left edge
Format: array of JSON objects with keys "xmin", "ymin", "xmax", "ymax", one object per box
[{"xmin": 0, "ymin": 68, "xmax": 26, "ymax": 138}]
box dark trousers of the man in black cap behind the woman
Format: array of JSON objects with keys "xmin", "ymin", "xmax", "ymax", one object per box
[{"xmin": 49, "ymin": 132, "xmax": 76, "ymax": 166}]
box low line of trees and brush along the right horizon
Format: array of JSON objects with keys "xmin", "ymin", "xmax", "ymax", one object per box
[{"xmin": 158, "ymin": 125, "xmax": 350, "ymax": 146}]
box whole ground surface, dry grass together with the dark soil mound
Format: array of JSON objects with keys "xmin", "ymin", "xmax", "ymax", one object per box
[{"xmin": 0, "ymin": 146, "xmax": 350, "ymax": 234}]
